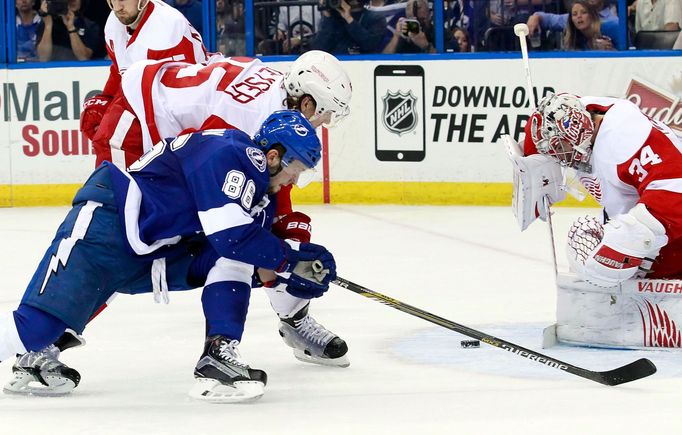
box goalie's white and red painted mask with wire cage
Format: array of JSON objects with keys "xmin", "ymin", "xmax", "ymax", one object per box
[{"xmin": 528, "ymin": 94, "xmax": 594, "ymax": 172}]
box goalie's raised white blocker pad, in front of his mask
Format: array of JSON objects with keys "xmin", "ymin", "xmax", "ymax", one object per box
[{"xmin": 501, "ymin": 135, "xmax": 566, "ymax": 231}]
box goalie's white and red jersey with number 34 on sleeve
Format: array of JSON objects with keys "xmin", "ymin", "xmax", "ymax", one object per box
[{"xmin": 568, "ymin": 97, "xmax": 682, "ymax": 278}]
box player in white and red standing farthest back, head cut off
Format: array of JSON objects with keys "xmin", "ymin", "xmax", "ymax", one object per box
[{"xmin": 81, "ymin": 0, "xmax": 207, "ymax": 152}]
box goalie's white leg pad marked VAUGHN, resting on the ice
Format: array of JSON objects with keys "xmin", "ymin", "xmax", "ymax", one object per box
[{"xmin": 545, "ymin": 273, "xmax": 682, "ymax": 349}]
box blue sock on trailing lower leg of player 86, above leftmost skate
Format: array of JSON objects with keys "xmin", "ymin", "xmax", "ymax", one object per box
[{"xmin": 13, "ymin": 304, "xmax": 68, "ymax": 351}]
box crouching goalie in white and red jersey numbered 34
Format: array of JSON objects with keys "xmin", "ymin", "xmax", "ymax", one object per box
[{"xmin": 507, "ymin": 94, "xmax": 682, "ymax": 347}]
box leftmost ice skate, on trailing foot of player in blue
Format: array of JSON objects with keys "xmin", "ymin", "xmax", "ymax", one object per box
[{"xmin": 3, "ymin": 345, "xmax": 81, "ymax": 396}]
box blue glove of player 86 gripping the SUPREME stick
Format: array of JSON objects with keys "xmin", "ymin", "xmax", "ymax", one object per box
[{"xmin": 277, "ymin": 240, "xmax": 336, "ymax": 299}]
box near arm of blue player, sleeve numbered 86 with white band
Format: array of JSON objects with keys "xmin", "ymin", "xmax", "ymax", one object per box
[{"xmin": 182, "ymin": 134, "xmax": 287, "ymax": 270}]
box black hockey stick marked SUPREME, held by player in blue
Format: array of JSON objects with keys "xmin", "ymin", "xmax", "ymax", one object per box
[{"xmin": 330, "ymin": 278, "xmax": 656, "ymax": 385}]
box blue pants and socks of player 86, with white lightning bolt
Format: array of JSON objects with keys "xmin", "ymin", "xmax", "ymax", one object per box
[{"xmin": 0, "ymin": 166, "xmax": 253, "ymax": 361}]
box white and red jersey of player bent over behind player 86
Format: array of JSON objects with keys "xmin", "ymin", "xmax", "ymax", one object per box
[{"xmin": 122, "ymin": 56, "xmax": 287, "ymax": 151}]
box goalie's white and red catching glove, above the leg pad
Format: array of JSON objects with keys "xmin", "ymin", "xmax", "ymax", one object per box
[{"xmin": 567, "ymin": 204, "xmax": 668, "ymax": 287}]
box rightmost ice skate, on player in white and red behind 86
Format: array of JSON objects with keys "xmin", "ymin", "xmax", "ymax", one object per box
[{"xmin": 279, "ymin": 305, "xmax": 350, "ymax": 367}]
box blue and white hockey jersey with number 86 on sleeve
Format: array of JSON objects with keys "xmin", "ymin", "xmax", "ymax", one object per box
[{"xmin": 105, "ymin": 130, "xmax": 286, "ymax": 269}]
